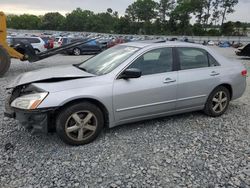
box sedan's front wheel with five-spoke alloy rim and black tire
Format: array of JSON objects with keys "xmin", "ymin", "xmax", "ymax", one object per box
[{"xmin": 56, "ymin": 102, "xmax": 104, "ymax": 146}]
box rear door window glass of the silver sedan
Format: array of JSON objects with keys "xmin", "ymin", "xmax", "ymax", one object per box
[{"xmin": 177, "ymin": 48, "xmax": 209, "ymax": 70}]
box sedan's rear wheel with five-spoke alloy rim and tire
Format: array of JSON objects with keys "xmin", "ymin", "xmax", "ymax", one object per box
[{"xmin": 204, "ymin": 86, "xmax": 231, "ymax": 117}]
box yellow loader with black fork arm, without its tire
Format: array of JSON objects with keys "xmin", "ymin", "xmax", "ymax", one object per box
[{"xmin": 0, "ymin": 11, "xmax": 95, "ymax": 77}]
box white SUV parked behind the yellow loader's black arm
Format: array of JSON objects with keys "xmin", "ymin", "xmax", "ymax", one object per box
[{"xmin": 7, "ymin": 37, "xmax": 46, "ymax": 53}]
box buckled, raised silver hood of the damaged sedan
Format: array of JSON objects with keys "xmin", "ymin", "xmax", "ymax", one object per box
[{"xmin": 7, "ymin": 65, "xmax": 95, "ymax": 89}]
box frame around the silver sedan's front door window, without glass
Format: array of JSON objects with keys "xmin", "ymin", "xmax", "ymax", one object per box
[{"xmin": 115, "ymin": 46, "xmax": 177, "ymax": 80}]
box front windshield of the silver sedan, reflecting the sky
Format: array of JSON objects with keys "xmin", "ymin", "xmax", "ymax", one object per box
[{"xmin": 79, "ymin": 46, "xmax": 139, "ymax": 75}]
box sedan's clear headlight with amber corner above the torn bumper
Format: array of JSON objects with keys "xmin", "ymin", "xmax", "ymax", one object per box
[{"xmin": 11, "ymin": 92, "xmax": 48, "ymax": 110}]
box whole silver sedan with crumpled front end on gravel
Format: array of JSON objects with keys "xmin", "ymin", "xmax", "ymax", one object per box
[{"xmin": 5, "ymin": 42, "xmax": 247, "ymax": 145}]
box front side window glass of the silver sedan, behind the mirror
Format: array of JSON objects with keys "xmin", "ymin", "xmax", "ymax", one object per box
[{"xmin": 129, "ymin": 48, "xmax": 173, "ymax": 75}]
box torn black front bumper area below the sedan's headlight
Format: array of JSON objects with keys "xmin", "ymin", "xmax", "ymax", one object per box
[{"xmin": 4, "ymin": 96, "xmax": 55, "ymax": 134}]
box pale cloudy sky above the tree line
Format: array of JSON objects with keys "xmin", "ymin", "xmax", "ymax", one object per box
[{"xmin": 0, "ymin": 0, "xmax": 250, "ymax": 22}]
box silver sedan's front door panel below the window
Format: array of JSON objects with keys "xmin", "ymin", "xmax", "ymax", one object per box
[{"xmin": 113, "ymin": 72, "xmax": 177, "ymax": 121}]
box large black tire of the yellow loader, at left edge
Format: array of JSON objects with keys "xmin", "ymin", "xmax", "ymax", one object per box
[{"xmin": 0, "ymin": 45, "xmax": 10, "ymax": 77}]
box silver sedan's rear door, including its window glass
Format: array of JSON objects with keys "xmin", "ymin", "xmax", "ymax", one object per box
[{"xmin": 176, "ymin": 47, "xmax": 221, "ymax": 110}]
